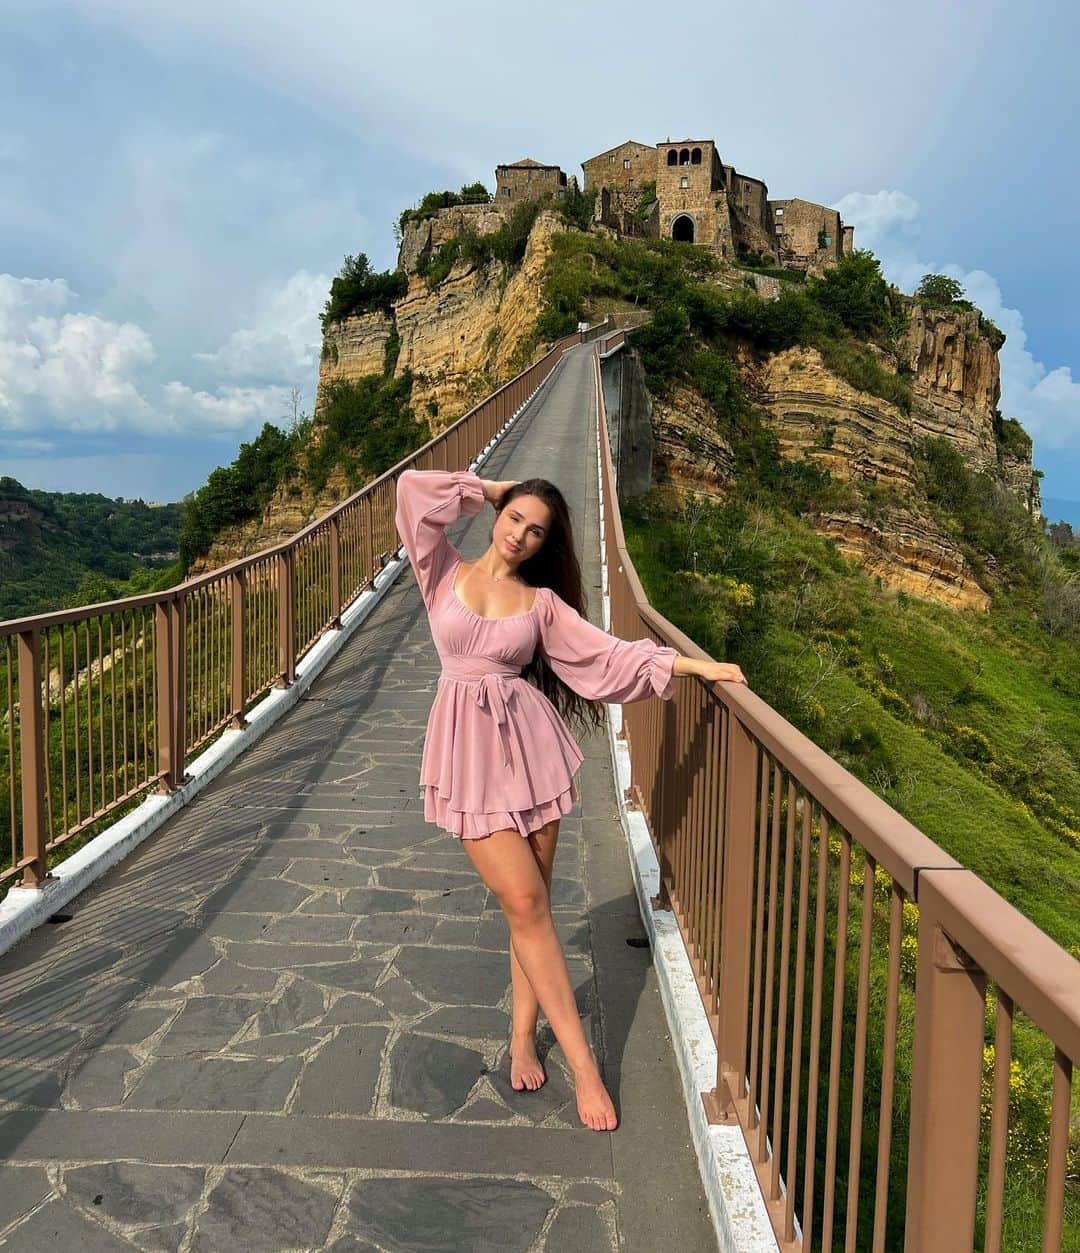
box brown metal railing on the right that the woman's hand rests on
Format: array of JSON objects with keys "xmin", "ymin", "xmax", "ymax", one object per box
[{"xmin": 595, "ymin": 337, "xmax": 1080, "ymax": 1253}]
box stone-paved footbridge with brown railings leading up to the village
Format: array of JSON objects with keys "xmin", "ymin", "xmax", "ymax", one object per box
[{"xmin": 0, "ymin": 328, "xmax": 1080, "ymax": 1253}]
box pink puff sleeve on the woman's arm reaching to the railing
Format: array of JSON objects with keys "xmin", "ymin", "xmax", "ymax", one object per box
[{"xmin": 536, "ymin": 588, "xmax": 679, "ymax": 704}]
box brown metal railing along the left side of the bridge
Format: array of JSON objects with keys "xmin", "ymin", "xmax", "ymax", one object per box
[{"xmin": 0, "ymin": 323, "xmax": 591, "ymax": 891}]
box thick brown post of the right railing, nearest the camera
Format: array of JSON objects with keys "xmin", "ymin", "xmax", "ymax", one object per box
[{"xmin": 905, "ymin": 887, "xmax": 986, "ymax": 1253}]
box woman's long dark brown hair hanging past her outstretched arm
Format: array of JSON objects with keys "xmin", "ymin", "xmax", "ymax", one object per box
[{"xmin": 496, "ymin": 479, "xmax": 604, "ymax": 732}]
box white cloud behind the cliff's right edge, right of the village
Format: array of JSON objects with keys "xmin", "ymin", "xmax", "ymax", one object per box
[{"xmin": 837, "ymin": 190, "xmax": 1080, "ymax": 461}]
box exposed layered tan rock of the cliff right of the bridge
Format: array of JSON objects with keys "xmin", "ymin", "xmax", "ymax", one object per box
[{"xmin": 654, "ymin": 304, "xmax": 1039, "ymax": 609}]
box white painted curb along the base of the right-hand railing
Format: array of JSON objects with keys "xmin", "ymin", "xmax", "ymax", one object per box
[{"xmin": 596, "ymin": 393, "xmax": 777, "ymax": 1253}]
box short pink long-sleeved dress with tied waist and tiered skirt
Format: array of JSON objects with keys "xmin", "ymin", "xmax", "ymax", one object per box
[{"xmin": 395, "ymin": 470, "xmax": 679, "ymax": 840}]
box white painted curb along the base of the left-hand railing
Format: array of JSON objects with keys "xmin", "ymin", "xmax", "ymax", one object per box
[{"xmin": 0, "ymin": 353, "xmax": 565, "ymax": 954}]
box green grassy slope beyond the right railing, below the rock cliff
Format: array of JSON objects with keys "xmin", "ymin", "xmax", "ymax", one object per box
[{"xmin": 625, "ymin": 498, "xmax": 1080, "ymax": 952}]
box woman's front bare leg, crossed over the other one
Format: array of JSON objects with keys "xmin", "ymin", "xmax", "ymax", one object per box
[{"xmin": 462, "ymin": 831, "xmax": 618, "ymax": 1131}]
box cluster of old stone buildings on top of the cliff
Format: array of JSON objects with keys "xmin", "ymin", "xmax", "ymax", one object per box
[{"xmin": 495, "ymin": 139, "xmax": 854, "ymax": 273}]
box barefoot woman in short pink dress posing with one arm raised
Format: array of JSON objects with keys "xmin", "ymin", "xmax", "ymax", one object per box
[{"xmin": 395, "ymin": 470, "xmax": 745, "ymax": 1131}]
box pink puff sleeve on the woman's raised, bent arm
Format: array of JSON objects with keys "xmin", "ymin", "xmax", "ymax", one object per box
[{"xmin": 393, "ymin": 470, "xmax": 484, "ymax": 609}]
